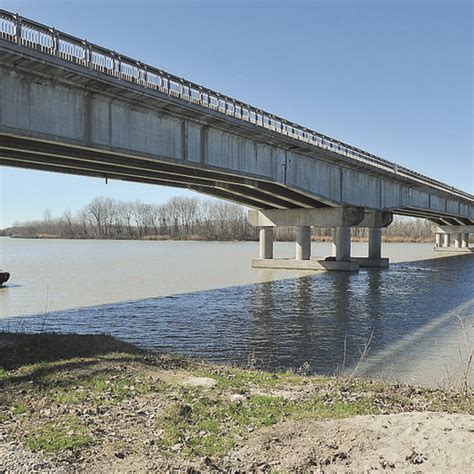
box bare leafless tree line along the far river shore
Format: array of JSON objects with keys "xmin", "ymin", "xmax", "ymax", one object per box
[{"xmin": 0, "ymin": 196, "xmax": 433, "ymax": 241}]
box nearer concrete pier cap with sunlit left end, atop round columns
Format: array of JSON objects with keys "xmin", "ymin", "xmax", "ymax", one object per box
[{"xmin": 248, "ymin": 206, "xmax": 365, "ymax": 227}]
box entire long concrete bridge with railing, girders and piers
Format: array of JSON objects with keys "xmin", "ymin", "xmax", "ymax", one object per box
[{"xmin": 0, "ymin": 10, "xmax": 474, "ymax": 271}]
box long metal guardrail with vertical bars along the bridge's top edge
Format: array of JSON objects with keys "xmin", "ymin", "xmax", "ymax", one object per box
[{"xmin": 0, "ymin": 10, "xmax": 474, "ymax": 201}]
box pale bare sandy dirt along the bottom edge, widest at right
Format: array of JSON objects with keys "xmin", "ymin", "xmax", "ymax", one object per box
[{"xmin": 0, "ymin": 412, "xmax": 474, "ymax": 473}]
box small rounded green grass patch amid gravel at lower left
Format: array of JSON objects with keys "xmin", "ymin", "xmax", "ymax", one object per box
[{"xmin": 26, "ymin": 416, "xmax": 93, "ymax": 454}]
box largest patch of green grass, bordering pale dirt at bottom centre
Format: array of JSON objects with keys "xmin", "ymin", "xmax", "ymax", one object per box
[{"xmin": 158, "ymin": 388, "xmax": 377, "ymax": 457}]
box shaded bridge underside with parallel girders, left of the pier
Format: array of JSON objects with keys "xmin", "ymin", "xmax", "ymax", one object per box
[{"xmin": 0, "ymin": 134, "xmax": 328, "ymax": 209}]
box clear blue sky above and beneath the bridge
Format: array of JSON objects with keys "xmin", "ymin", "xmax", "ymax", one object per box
[{"xmin": 0, "ymin": 0, "xmax": 474, "ymax": 228}]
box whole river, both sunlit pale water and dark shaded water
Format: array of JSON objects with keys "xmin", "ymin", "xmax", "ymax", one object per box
[{"xmin": 0, "ymin": 238, "xmax": 474, "ymax": 386}]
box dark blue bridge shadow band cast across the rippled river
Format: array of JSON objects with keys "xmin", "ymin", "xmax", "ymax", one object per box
[{"xmin": 0, "ymin": 256, "xmax": 474, "ymax": 374}]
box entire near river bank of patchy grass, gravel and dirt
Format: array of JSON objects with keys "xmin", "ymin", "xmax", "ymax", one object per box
[{"xmin": 0, "ymin": 333, "xmax": 474, "ymax": 472}]
